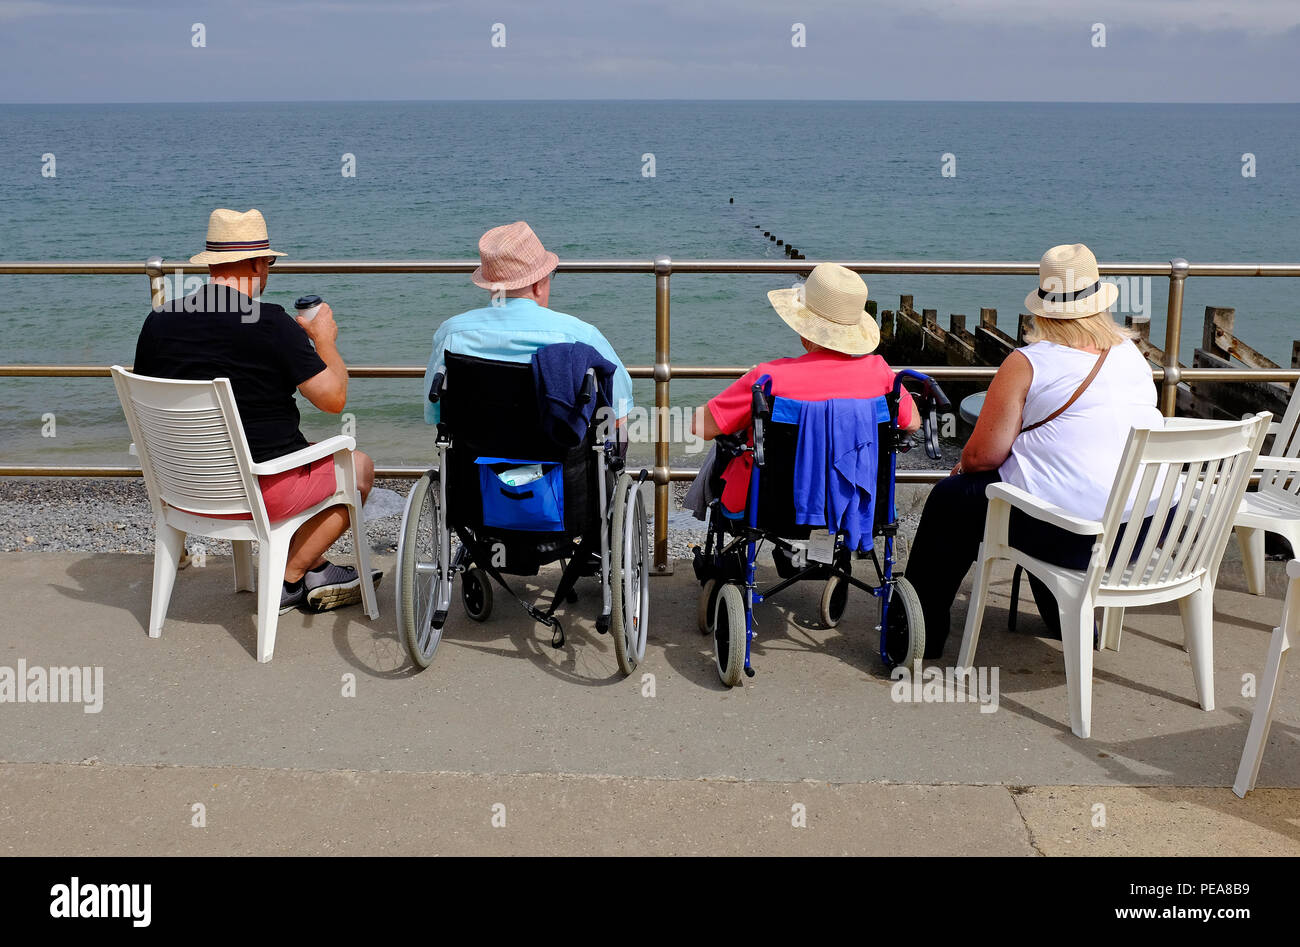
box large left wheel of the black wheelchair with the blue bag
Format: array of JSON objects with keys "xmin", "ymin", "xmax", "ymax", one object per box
[{"xmin": 397, "ymin": 470, "xmax": 451, "ymax": 667}]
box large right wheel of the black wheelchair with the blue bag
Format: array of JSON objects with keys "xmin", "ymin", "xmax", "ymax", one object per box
[{"xmin": 610, "ymin": 472, "xmax": 650, "ymax": 674}]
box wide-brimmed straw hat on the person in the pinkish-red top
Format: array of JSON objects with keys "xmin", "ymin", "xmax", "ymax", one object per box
[{"xmin": 767, "ymin": 263, "xmax": 880, "ymax": 355}]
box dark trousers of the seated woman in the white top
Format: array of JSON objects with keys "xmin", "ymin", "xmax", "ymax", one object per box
[{"xmin": 906, "ymin": 470, "xmax": 1096, "ymax": 658}]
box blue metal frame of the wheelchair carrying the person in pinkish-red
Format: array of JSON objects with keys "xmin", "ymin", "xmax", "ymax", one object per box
[{"xmin": 710, "ymin": 369, "xmax": 952, "ymax": 678}]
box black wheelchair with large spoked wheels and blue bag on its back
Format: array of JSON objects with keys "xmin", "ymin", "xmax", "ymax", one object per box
[{"xmin": 397, "ymin": 353, "xmax": 650, "ymax": 675}]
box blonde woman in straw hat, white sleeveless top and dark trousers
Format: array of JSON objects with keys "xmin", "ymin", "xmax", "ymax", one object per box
[{"xmin": 906, "ymin": 243, "xmax": 1164, "ymax": 658}]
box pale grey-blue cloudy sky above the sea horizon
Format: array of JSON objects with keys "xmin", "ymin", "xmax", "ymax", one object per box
[{"xmin": 0, "ymin": 0, "xmax": 1300, "ymax": 104}]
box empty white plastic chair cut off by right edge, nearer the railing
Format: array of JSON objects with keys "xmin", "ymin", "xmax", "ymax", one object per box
[{"xmin": 1234, "ymin": 386, "xmax": 1300, "ymax": 596}]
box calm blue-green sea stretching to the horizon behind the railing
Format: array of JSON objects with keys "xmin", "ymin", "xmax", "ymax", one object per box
[{"xmin": 0, "ymin": 101, "xmax": 1300, "ymax": 466}]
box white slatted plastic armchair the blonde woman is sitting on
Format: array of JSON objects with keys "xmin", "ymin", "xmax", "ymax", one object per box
[{"xmin": 958, "ymin": 412, "xmax": 1271, "ymax": 738}]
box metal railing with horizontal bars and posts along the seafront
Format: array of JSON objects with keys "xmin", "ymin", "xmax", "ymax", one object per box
[{"xmin": 0, "ymin": 256, "xmax": 1300, "ymax": 574}]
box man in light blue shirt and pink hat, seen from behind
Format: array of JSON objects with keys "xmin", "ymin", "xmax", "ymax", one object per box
[{"xmin": 424, "ymin": 220, "xmax": 632, "ymax": 424}]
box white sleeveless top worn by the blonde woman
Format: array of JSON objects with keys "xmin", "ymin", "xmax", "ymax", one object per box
[{"xmin": 998, "ymin": 340, "xmax": 1165, "ymax": 519}]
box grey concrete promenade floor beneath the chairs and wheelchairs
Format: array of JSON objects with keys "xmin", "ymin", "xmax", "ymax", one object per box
[{"xmin": 0, "ymin": 545, "xmax": 1300, "ymax": 855}]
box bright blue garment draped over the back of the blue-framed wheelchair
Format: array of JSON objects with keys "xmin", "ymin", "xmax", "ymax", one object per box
[{"xmin": 794, "ymin": 398, "xmax": 888, "ymax": 552}]
